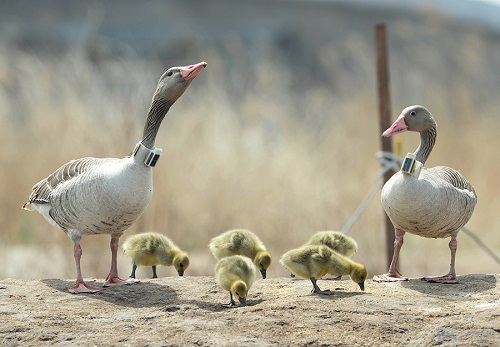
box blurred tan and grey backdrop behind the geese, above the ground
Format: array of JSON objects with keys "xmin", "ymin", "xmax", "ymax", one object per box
[{"xmin": 0, "ymin": 0, "xmax": 500, "ymax": 279}]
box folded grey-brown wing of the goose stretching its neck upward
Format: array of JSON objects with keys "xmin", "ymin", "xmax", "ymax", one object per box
[{"xmin": 23, "ymin": 157, "xmax": 105, "ymax": 208}]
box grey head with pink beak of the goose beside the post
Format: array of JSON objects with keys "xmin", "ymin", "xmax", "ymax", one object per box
[{"xmin": 382, "ymin": 105, "xmax": 436, "ymax": 137}]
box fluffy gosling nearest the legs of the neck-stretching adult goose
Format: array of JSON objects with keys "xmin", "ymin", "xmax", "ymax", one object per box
[{"xmin": 122, "ymin": 232, "xmax": 189, "ymax": 278}]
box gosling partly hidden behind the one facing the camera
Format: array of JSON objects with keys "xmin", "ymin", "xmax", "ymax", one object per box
[{"xmin": 208, "ymin": 229, "xmax": 271, "ymax": 278}]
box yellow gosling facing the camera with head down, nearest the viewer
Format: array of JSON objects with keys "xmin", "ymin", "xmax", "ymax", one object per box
[{"xmin": 215, "ymin": 255, "xmax": 256, "ymax": 308}]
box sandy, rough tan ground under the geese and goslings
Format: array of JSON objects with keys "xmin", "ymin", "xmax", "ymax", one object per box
[{"xmin": 0, "ymin": 274, "xmax": 500, "ymax": 346}]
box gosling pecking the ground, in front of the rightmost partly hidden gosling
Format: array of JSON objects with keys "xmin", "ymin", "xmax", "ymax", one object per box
[{"xmin": 280, "ymin": 245, "xmax": 368, "ymax": 295}]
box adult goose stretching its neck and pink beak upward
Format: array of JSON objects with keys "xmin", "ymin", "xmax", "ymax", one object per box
[{"xmin": 23, "ymin": 62, "xmax": 207, "ymax": 293}]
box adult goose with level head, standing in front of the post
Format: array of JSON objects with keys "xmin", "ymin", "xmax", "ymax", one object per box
[{"xmin": 373, "ymin": 105, "xmax": 477, "ymax": 283}]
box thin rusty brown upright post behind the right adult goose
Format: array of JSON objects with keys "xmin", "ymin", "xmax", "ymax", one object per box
[{"xmin": 375, "ymin": 24, "xmax": 395, "ymax": 267}]
